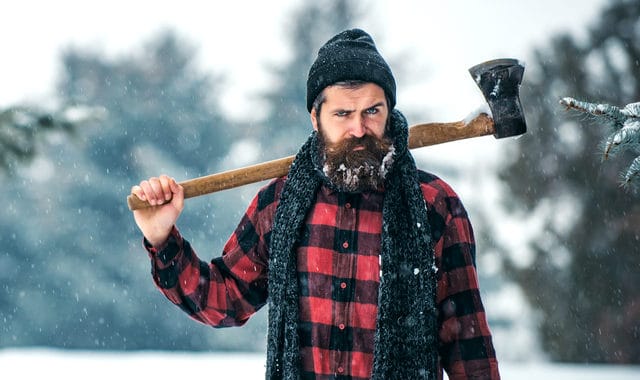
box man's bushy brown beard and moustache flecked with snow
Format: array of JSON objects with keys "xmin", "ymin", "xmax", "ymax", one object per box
[{"xmin": 318, "ymin": 126, "xmax": 395, "ymax": 193}]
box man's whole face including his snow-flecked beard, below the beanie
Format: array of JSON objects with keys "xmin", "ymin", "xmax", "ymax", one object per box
[{"xmin": 311, "ymin": 84, "xmax": 393, "ymax": 192}]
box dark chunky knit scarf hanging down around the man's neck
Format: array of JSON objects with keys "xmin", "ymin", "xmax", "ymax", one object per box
[{"xmin": 266, "ymin": 110, "xmax": 438, "ymax": 380}]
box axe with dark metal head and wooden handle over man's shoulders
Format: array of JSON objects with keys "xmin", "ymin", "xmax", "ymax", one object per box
[{"xmin": 127, "ymin": 58, "xmax": 527, "ymax": 210}]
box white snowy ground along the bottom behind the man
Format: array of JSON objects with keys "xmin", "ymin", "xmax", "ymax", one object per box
[{"xmin": 0, "ymin": 349, "xmax": 640, "ymax": 380}]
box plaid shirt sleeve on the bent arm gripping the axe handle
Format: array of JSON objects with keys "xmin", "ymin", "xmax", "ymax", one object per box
[{"xmin": 144, "ymin": 178, "xmax": 277, "ymax": 327}]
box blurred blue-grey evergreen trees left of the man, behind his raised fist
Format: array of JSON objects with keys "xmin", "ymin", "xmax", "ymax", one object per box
[{"xmin": 0, "ymin": 29, "xmax": 259, "ymax": 349}]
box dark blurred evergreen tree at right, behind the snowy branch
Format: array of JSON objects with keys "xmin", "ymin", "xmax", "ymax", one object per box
[{"xmin": 497, "ymin": 0, "xmax": 640, "ymax": 363}]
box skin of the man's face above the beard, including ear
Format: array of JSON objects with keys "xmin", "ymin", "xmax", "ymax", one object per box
[{"xmin": 311, "ymin": 83, "xmax": 389, "ymax": 144}]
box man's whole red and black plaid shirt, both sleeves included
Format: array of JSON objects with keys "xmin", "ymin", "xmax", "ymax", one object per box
[{"xmin": 145, "ymin": 172, "xmax": 499, "ymax": 379}]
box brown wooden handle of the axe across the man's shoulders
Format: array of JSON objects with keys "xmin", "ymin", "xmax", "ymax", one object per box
[{"xmin": 127, "ymin": 113, "xmax": 495, "ymax": 210}]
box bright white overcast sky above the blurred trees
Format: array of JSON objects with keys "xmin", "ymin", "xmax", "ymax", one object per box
[{"xmin": 0, "ymin": 0, "xmax": 606, "ymax": 118}]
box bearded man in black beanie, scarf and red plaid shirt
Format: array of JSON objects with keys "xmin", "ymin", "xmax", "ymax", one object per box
[{"xmin": 132, "ymin": 29, "xmax": 499, "ymax": 380}]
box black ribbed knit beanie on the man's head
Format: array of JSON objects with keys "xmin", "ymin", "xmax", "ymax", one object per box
[{"xmin": 307, "ymin": 29, "xmax": 396, "ymax": 112}]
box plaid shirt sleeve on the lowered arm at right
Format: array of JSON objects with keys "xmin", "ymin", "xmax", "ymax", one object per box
[{"xmin": 425, "ymin": 180, "xmax": 500, "ymax": 380}]
